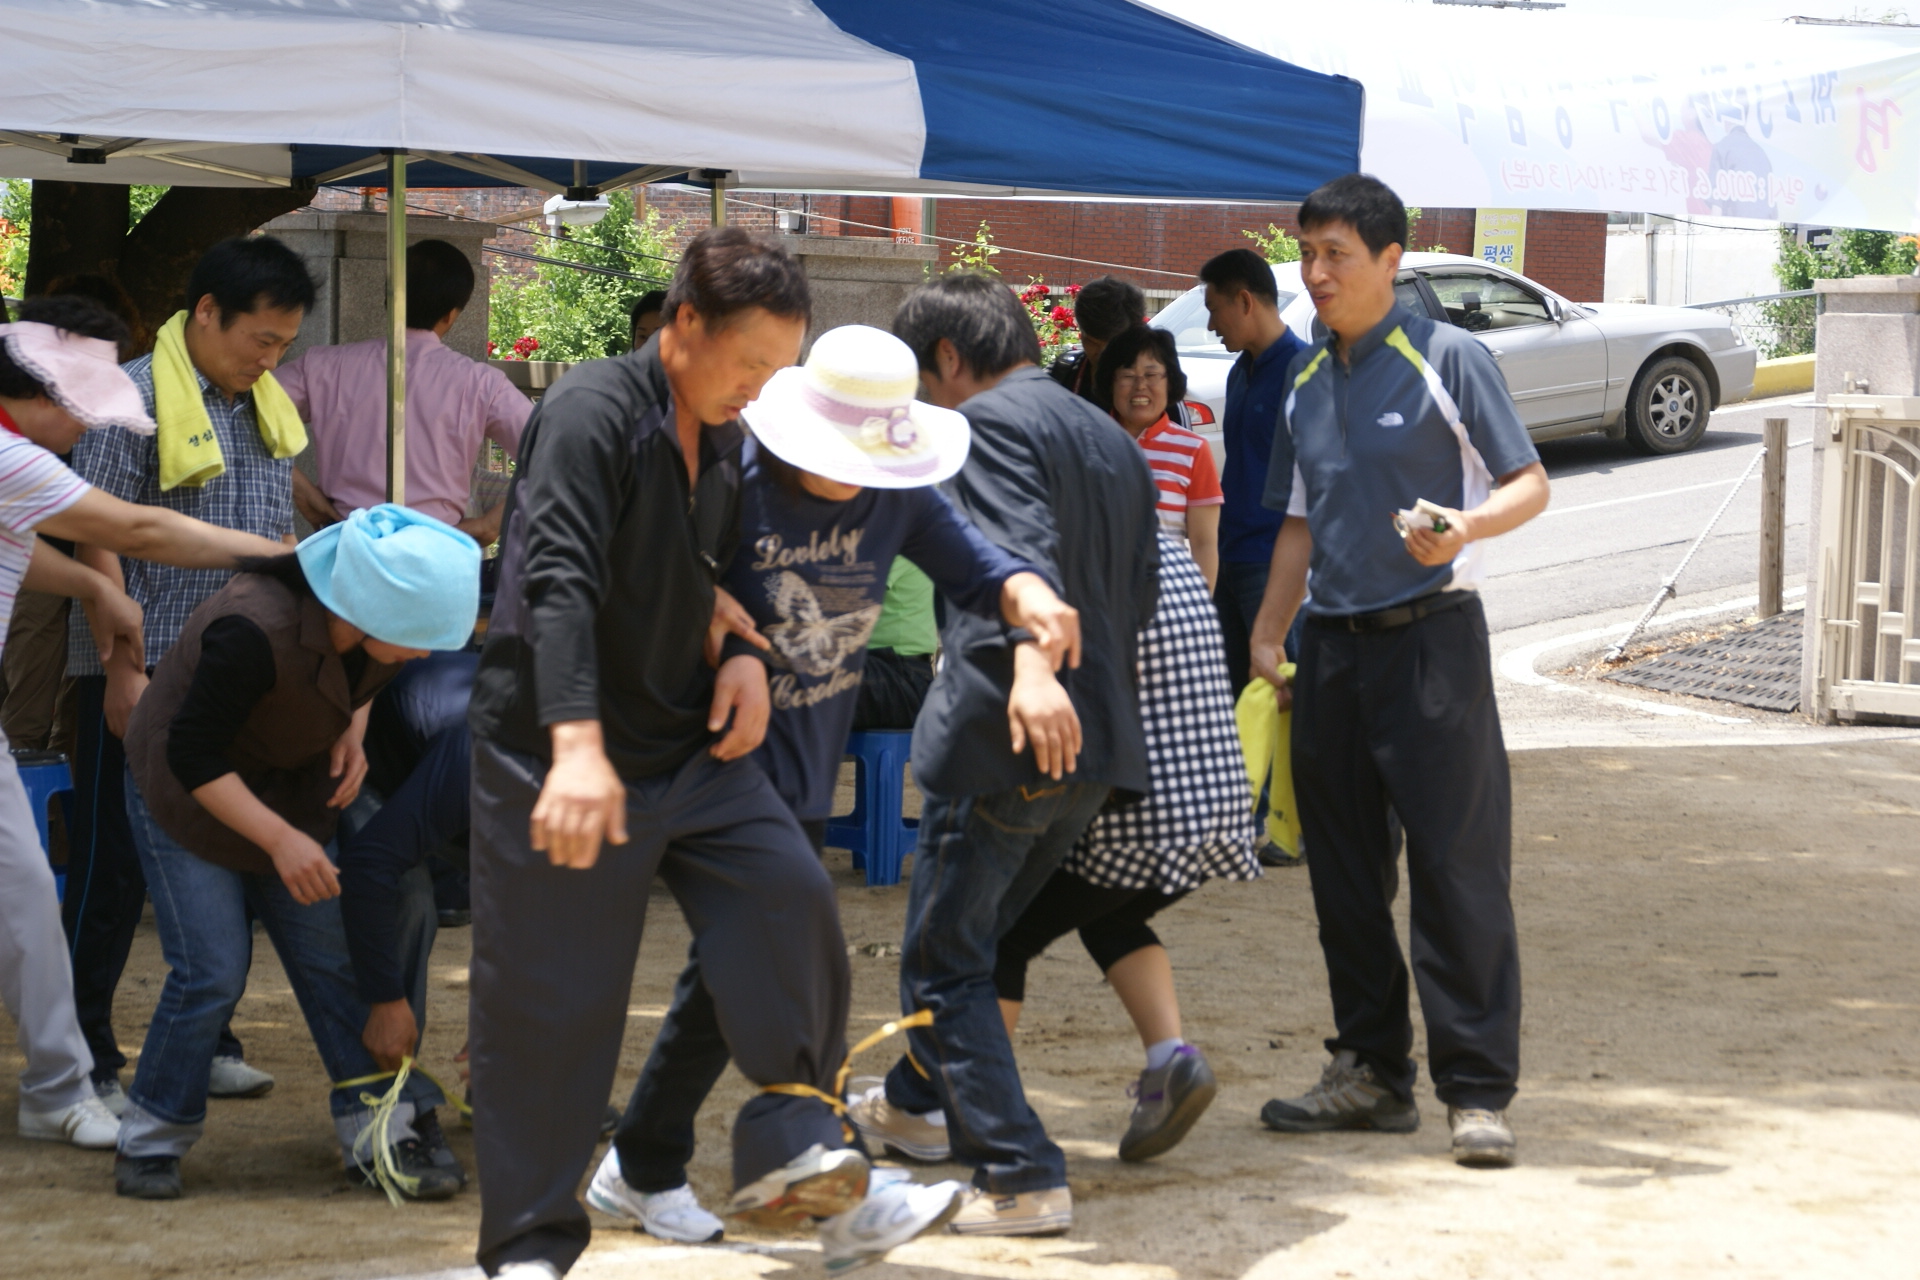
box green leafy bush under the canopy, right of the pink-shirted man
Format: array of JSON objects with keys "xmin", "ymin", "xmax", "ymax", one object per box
[{"xmin": 488, "ymin": 192, "xmax": 680, "ymax": 361}]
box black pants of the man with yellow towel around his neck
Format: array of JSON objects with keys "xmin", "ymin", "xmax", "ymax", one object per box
[{"xmin": 60, "ymin": 676, "xmax": 244, "ymax": 1080}]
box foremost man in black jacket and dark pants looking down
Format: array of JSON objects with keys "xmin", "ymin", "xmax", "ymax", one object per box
[{"xmin": 460, "ymin": 230, "xmax": 866, "ymax": 1274}]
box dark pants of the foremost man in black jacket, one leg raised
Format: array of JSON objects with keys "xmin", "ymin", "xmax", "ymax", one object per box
[{"xmin": 470, "ymin": 739, "xmax": 851, "ymax": 1274}]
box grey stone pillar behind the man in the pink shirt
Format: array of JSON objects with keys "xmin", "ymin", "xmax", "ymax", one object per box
[{"xmin": 265, "ymin": 213, "xmax": 499, "ymax": 361}]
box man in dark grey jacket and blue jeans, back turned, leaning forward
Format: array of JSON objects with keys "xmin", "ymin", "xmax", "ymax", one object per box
[{"xmin": 849, "ymin": 274, "xmax": 1160, "ymax": 1236}]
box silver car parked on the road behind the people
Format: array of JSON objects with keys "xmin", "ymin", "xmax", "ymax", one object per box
[{"xmin": 1152, "ymin": 253, "xmax": 1759, "ymax": 453}]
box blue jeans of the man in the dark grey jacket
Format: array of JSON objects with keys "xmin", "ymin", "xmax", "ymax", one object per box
[{"xmin": 887, "ymin": 783, "xmax": 1108, "ymax": 1196}]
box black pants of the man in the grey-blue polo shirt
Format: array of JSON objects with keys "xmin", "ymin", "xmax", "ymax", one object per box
[{"xmin": 1292, "ymin": 599, "xmax": 1521, "ymax": 1109}]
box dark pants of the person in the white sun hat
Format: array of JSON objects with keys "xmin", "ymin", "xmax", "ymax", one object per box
[{"xmin": 612, "ymin": 818, "xmax": 828, "ymax": 1194}]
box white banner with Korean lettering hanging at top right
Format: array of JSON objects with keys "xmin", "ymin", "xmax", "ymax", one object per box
[{"xmin": 1150, "ymin": 0, "xmax": 1920, "ymax": 230}]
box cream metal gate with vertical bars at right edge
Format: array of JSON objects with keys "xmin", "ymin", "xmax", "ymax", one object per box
[{"xmin": 1812, "ymin": 395, "xmax": 1920, "ymax": 720}]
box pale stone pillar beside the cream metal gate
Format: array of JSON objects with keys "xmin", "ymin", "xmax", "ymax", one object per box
[{"xmin": 1801, "ymin": 276, "xmax": 1920, "ymax": 710}]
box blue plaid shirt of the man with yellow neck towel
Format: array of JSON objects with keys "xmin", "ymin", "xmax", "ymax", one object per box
[{"xmin": 67, "ymin": 355, "xmax": 294, "ymax": 676}]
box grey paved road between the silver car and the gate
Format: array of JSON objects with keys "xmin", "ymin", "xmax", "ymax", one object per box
[{"xmin": 1484, "ymin": 397, "xmax": 1814, "ymax": 631}]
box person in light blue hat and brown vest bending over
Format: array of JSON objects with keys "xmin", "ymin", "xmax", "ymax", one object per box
[{"xmin": 115, "ymin": 505, "xmax": 480, "ymax": 1199}]
